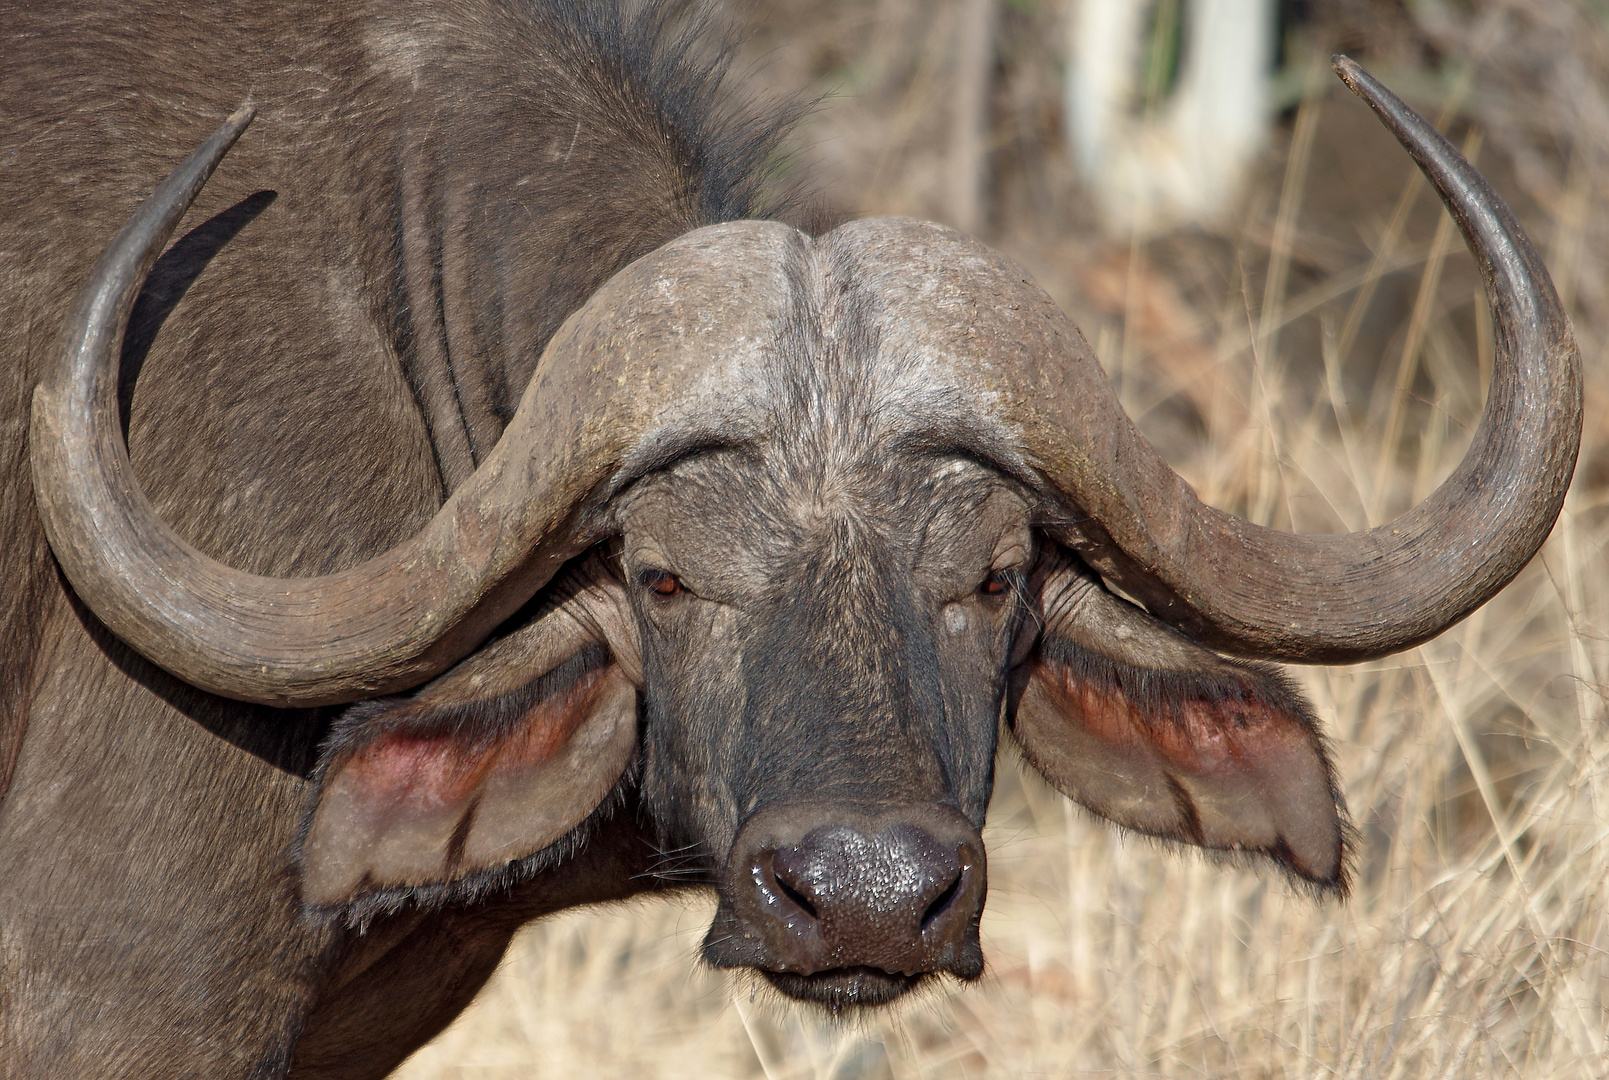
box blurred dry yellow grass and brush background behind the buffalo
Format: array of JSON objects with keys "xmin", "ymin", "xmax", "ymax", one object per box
[{"xmin": 402, "ymin": 0, "xmax": 1609, "ymax": 1080}]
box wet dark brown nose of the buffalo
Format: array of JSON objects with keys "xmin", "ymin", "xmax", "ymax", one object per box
[{"xmin": 705, "ymin": 803, "xmax": 985, "ymax": 979}]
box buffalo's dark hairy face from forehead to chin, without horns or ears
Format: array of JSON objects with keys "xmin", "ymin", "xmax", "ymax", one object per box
[{"xmin": 618, "ymin": 450, "xmax": 1033, "ymax": 1006}]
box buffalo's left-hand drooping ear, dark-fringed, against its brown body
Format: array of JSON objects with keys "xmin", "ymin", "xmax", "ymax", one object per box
[{"xmin": 299, "ymin": 624, "xmax": 637, "ymax": 906}]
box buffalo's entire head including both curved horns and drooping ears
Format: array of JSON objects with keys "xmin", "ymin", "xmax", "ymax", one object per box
[{"xmin": 32, "ymin": 61, "xmax": 1580, "ymax": 1004}]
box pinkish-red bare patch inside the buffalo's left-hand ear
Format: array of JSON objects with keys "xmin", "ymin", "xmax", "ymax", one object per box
[{"xmin": 339, "ymin": 668, "xmax": 607, "ymax": 811}]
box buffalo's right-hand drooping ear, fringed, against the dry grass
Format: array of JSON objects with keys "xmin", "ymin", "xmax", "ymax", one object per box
[{"xmin": 1012, "ymin": 559, "xmax": 1350, "ymax": 895}]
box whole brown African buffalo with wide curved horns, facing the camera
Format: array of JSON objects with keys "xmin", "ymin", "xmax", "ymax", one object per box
[{"xmin": 0, "ymin": 0, "xmax": 1580, "ymax": 1078}]
